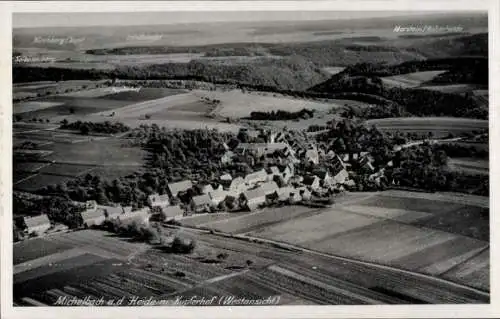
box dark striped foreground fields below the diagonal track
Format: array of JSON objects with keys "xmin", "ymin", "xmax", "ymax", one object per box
[{"xmin": 14, "ymin": 224, "xmax": 488, "ymax": 306}]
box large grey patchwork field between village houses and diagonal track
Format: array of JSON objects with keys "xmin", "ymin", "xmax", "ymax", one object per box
[{"xmin": 191, "ymin": 191, "xmax": 489, "ymax": 292}]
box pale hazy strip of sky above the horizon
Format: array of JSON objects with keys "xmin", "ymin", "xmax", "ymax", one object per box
[{"xmin": 12, "ymin": 11, "xmax": 450, "ymax": 28}]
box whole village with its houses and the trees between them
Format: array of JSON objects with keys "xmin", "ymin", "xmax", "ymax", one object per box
[{"xmin": 17, "ymin": 129, "xmax": 382, "ymax": 239}]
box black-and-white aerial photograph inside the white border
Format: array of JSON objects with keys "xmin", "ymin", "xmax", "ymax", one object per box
[{"xmin": 9, "ymin": 11, "xmax": 490, "ymax": 309}]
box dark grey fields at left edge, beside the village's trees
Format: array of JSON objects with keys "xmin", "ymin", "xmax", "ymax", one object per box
[{"xmin": 14, "ymin": 128, "xmax": 145, "ymax": 191}]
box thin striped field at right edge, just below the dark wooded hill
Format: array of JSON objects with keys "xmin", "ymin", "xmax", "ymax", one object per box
[{"xmin": 365, "ymin": 117, "xmax": 488, "ymax": 138}]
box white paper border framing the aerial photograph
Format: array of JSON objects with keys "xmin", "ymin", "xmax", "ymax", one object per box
[{"xmin": 0, "ymin": 0, "xmax": 500, "ymax": 319}]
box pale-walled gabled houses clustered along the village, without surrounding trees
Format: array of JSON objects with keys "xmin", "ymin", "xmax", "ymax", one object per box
[{"xmin": 18, "ymin": 130, "xmax": 389, "ymax": 239}]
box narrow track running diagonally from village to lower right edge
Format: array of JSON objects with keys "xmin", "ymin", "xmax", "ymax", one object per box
[{"xmin": 172, "ymin": 226, "xmax": 490, "ymax": 298}]
